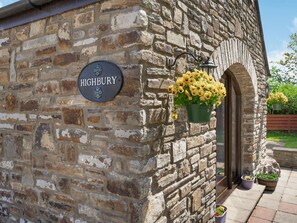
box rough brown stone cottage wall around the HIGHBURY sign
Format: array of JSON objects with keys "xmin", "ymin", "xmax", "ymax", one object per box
[{"xmin": 0, "ymin": 0, "xmax": 266, "ymax": 223}]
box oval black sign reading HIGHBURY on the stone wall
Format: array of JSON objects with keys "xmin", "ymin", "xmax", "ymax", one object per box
[{"xmin": 77, "ymin": 60, "xmax": 123, "ymax": 102}]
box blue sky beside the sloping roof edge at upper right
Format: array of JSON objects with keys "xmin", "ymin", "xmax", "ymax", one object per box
[{"xmin": 259, "ymin": 0, "xmax": 297, "ymax": 65}]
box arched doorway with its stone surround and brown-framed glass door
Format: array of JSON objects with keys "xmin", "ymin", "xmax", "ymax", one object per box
[{"xmin": 211, "ymin": 38, "xmax": 259, "ymax": 202}]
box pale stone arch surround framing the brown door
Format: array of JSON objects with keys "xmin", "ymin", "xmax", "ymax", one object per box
[{"xmin": 212, "ymin": 38, "xmax": 258, "ymax": 172}]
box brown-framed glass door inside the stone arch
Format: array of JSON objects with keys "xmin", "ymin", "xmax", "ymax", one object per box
[{"xmin": 216, "ymin": 70, "xmax": 242, "ymax": 201}]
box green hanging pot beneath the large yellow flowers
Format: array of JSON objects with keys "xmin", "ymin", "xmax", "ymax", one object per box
[{"xmin": 186, "ymin": 104, "xmax": 212, "ymax": 123}]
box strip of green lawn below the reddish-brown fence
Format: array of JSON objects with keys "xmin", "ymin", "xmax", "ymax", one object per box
[{"xmin": 267, "ymin": 131, "xmax": 297, "ymax": 149}]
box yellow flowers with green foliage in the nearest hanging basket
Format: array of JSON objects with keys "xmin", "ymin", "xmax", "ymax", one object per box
[{"xmin": 168, "ymin": 69, "xmax": 226, "ymax": 119}]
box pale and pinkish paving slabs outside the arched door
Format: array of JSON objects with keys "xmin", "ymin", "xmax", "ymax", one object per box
[{"xmin": 224, "ymin": 168, "xmax": 297, "ymax": 223}]
